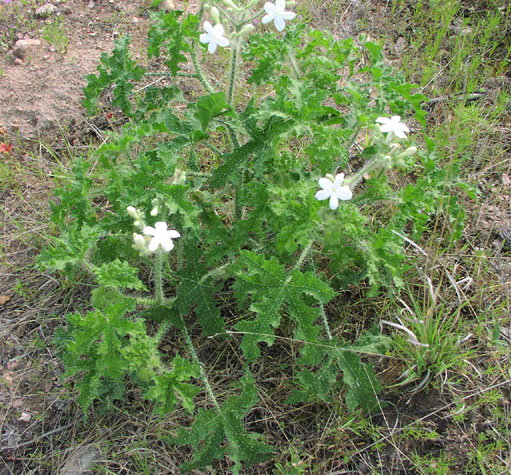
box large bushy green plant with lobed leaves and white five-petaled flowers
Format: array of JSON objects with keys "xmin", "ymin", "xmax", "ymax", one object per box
[{"xmin": 39, "ymin": 0, "xmax": 466, "ymax": 472}]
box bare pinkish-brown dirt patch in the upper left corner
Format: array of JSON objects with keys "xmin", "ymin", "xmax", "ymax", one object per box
[{"xmin": 0, "ymin": 0, "xmax": 156, "ymax": 140}]
